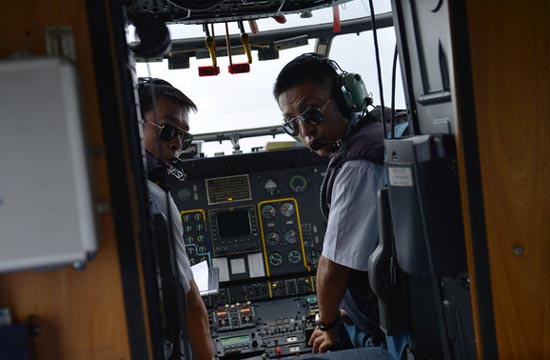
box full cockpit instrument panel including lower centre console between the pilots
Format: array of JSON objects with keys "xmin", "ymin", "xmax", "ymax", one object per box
[{"xmin": 172, "ymin": 148, "xmax": 326, "ymax": 360}]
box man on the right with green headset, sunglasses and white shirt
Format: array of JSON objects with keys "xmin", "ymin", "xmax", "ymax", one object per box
[{"xmin": 273, "ymin": 53, "xmax": 384, "ymax": 353}]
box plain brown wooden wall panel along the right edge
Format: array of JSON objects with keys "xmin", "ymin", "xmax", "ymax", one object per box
[{"xmin": 466, "ymin": 0, "xmax": 550, "ymax": 359}]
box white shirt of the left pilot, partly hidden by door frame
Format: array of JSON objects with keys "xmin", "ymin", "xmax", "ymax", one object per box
[{"xmin": 147, "ymin": 180, "xmax": 193, "ymax": 294}]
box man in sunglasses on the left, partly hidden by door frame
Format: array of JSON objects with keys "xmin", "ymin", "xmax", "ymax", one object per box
[{"xmin": 138, "ymin": 78, "xmax": 214, "ymax": 360}]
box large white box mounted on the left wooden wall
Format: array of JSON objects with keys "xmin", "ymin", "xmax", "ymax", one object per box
[{"xmin": 0, "ymin": 57, "xmax": 97, "ymax": 272}]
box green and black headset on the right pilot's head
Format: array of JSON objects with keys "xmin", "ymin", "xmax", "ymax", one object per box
[{"xmin": 301, "ymin": 53, "xmax": 373, "ymax": 118}]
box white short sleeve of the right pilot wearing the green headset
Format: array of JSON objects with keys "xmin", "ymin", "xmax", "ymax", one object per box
[{"xmin": 323, "ymin": 160, "xmax": 384, "ymax": 271}]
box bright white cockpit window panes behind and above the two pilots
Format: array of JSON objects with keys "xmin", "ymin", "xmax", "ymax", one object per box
[{"xmin": 136, "ymin": 0, "xmax": 404, "ymax": 156}]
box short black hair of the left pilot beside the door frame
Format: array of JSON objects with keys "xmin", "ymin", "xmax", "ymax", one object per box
[{"xmin": 138, "ymin": 78, "xmax": 197, "ymax": 116}]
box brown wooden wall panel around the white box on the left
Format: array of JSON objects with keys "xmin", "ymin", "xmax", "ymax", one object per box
[{"xmin": 0, "ymin": 0, "xmax": 130, "ymax": 360}]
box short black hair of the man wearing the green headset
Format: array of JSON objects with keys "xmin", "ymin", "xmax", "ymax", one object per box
[{"xmin": 273, "ymin": 53, "xmax": 338, "ymax": 101}]
